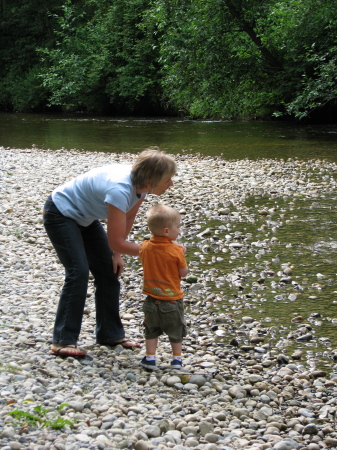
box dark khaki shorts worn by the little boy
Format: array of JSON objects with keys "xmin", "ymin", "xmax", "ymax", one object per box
[{"xmin": 143, "ymin": 295, "xmax": 187, "ymax": 343}]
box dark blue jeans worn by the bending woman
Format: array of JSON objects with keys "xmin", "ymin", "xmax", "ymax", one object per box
[{"xmin": 43, "ymin": 197, "xmax": 125, "ymax": 344}]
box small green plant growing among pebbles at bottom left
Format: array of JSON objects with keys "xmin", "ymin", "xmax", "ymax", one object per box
[{"xmin": 9, "ymin": 403, "xmax": 74, "ymax": 429}]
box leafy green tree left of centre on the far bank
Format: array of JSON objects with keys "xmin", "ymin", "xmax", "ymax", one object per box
[{"xmin": 40, "ymin": 0, "xmax": 159, "ymax": 111}]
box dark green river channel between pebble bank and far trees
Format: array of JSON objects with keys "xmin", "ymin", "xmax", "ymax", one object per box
[{"xmin": 0, "ymin": 114, "xmax": 337, "ymax": 161}]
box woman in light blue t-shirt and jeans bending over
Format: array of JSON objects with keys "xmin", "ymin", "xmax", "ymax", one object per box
[{"xmin": 43, "ymin": 149, "xmax": 176, "ymax": 356}]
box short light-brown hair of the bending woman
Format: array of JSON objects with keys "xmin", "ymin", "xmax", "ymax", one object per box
[{"xmin": 131, "ymin": 148, "xmax": 177, "ymax": 189}]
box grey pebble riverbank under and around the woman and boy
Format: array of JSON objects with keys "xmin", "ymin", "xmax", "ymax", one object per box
[{"xmin": 0, "ymin": 148, "xmax": 337, "ymax": 450}]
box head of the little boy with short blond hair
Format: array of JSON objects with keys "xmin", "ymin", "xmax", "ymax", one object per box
[{"xmin": 147, "ymin": 204, "xmax": 180, "ymax": 240}]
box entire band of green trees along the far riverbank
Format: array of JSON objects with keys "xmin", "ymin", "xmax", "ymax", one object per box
[{"xmin": 0, "ymin": 0, "xmax": 337, "ymax": 119}]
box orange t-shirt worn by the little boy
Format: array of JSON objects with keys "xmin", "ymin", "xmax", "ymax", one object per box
[{"xmin": 139, "ymin": 236, "xmax": 187, "ymax": 300}]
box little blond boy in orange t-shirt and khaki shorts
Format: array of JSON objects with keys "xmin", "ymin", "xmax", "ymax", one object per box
[{"xmin": 139, "ymin": 204, "xmax": 188, "ymax": 370}]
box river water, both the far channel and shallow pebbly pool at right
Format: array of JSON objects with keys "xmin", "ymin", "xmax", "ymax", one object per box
[{"xmin": 0, "ymin": 114, "xmax": 337, "ymax": 366}]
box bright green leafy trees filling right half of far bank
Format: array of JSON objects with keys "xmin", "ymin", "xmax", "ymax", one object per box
[{"xmin": 148, "ymin": 0, "xmax": 337, "ymax": 119}]
